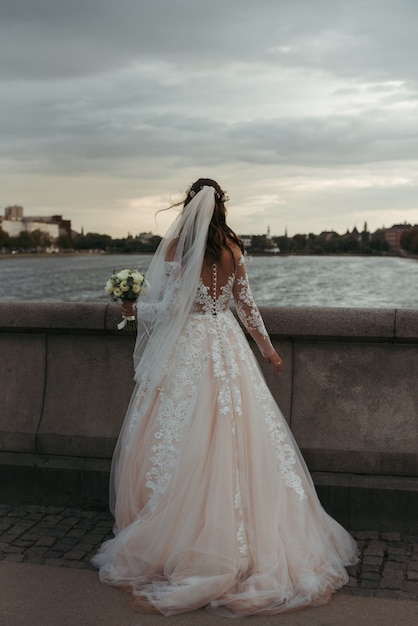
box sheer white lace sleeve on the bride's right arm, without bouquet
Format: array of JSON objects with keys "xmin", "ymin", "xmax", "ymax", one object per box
[{"xmin": 232, "ymin": 256, "xmax": 274, "ymax": 358}]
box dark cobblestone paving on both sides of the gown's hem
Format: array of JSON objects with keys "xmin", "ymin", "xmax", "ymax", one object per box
[{"xmin": 0, "ymin": 504, "xmax": 418, "ymax": 600}]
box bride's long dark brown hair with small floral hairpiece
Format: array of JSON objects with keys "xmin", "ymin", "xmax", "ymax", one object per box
[{"xmin": 183, "ymin": 178, "xmax": 244, "ymax": 261}]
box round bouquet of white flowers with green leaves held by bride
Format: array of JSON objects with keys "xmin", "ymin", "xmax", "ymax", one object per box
[{"xmin": 105, "ymin": 270, "xmax": 150, "ymax": 330}]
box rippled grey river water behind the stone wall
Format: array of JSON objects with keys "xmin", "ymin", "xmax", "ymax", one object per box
[{"xmin": 0, "ymin": 254, "xmax": 418, "ymax": 308}]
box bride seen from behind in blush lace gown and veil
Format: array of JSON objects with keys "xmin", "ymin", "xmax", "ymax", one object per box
[{"xmin": 93, "ymin": 179, "xmax": 357, "ymax": 616}]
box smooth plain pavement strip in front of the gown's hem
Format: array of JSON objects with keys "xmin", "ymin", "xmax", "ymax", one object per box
[{"xmin": 0, "ymin": 562, "xmax": 418, "ymax": 626}]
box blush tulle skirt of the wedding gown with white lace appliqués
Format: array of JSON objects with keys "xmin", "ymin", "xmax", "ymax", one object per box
[{"xmin": 93, "ymin": 311, "xmax": 357, "ymax": 616}]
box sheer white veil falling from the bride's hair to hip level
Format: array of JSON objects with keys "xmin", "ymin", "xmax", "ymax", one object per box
[{"xmin": 134, "ymin": 186, "xmax": 215, "ymax": 386}]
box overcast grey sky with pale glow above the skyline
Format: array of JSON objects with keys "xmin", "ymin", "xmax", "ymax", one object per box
[{"xmin": 0, "ymin": 0, "xmax": 418, "ymax": 237}]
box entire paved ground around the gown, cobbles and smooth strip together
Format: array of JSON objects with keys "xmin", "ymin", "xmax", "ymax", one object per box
[{"xmin": 0, "ymin": 504, "xmax": 418, "ymax": 626}]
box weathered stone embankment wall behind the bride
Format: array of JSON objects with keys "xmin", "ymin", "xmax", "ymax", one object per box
[{"xmin": 0, "ymin": 303, "xmax": 418, "ymax": 529}]
